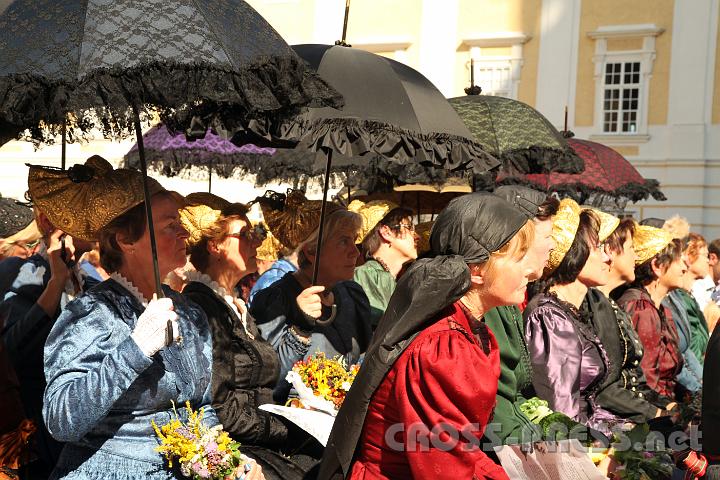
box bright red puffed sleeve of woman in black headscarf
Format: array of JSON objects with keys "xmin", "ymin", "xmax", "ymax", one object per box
[{"xmin": 391, "ymin": 330, "xmax": 508, "ymax": 479}]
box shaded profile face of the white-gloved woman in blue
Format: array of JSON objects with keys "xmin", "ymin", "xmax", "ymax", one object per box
[{"xmin": 130, "ymin": 195, "xmax": 189, "ymax": 278}]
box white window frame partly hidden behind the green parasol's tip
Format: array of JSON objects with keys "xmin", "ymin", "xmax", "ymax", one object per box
[{"xmin": 463, "ymin": 32, "xmax": 531, "ymax": 100}]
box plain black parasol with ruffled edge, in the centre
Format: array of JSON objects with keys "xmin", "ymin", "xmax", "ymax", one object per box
[{"xmin": 233, "ymin": 41, "xmax": 500, "ymax": 283}]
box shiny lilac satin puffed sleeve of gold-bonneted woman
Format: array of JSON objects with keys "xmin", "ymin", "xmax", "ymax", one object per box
[{"xmin": 525, "ymin": 305, "xmax": 582, "ymax": 421}]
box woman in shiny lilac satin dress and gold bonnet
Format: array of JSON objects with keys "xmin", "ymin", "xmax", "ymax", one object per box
[{"xmin": 523, "ymin": 199, "xmax": 618, "ymax": 433}]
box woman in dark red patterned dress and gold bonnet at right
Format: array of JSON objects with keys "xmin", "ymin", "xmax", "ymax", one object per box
[{"xmin": 617, "ymin": 225, "xmax": 686, "ymax": 404}]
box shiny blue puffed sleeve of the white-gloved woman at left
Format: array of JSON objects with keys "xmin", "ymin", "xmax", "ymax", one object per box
[{"xmin": 43, "ymin": 296, "xmax": 153, "ymax": 442}]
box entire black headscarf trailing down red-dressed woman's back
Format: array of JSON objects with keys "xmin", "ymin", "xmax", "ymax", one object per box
[{"xmin": 318, "ymin": 192, "xmax": 528, "ymax": 479}]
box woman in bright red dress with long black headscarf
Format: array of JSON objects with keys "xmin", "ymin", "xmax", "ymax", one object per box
[{"xmin": 319, "ymin": 193, "xmax": 534, "ymax": 479}]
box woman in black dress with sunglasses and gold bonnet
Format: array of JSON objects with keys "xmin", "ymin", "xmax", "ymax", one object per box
[{"xmin": 180, "ymin": 193, "xmax": 305, "ymax": 480}]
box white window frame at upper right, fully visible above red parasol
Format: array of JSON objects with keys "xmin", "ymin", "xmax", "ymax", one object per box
[{"xmin": 588, "ymin": 24, "xmax": 664, "ymax": 145}]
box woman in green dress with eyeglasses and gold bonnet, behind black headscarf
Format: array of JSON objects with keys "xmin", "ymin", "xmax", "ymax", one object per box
[{"xmin": 348, "ymin": 200, "xmax": 417, "ymax": 330}]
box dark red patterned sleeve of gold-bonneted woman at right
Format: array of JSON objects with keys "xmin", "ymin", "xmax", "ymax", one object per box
[{"xmin": 624, "ymin": 299, "xmax": 662, "ymax": 390}]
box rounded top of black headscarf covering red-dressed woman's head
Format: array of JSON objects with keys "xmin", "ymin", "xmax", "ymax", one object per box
[{"xmin": 430, "ymin": 192, "xmax": 528, "ymax": 263}]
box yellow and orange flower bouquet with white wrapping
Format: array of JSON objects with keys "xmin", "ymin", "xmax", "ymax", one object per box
[{"xmin": 286, "ymin": 352, "xmax": 360, "ymax": 416}]
